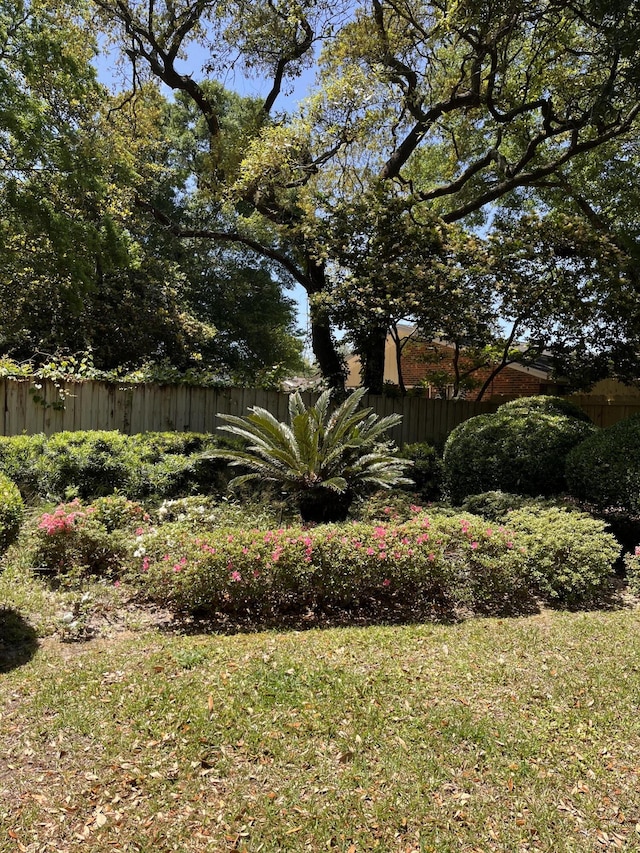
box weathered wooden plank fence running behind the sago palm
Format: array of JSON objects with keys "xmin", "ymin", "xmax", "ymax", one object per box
[{"xmin": 0, "ymin": 379, "xmax": 497, "ymax": 445}]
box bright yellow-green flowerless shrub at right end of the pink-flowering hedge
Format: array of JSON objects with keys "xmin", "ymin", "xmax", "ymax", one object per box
[{"xmin": 506, "ymin": 507, "xmax": 620, "ymax": 606}]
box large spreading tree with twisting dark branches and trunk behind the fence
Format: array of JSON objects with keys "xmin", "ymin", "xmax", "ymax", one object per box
[{"xmin": 86, "ymin": 0, "xmax": 640, "ymax": 386}]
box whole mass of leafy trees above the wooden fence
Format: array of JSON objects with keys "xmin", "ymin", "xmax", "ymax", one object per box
[{"xmin": 0, "ymin": 0, "xmax": 640, "ymax": 390}]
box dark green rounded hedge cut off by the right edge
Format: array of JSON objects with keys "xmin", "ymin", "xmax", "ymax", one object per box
[{"xmin": 567, "ymin": 415, "xmax": 640, "ymax": 515}]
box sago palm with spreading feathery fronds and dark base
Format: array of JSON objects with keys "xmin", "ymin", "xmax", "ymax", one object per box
[{"xmin": 208, "ymin": 389, "xmax": 411, "ymax": 521}]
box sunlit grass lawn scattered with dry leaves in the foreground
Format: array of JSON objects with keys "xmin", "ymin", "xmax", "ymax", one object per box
[{"xmin": 0, "ymin": 586, "xmax": 640, "ymax": 853}]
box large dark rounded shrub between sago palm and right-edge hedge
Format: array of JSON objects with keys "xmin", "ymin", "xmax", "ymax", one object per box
[{"xmin": 444, "ymin": 411, "xmax": 595, "ymax": 504}]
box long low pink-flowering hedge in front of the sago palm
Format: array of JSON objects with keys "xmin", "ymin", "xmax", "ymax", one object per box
[{"xmin": 128, "ymin": 507, "xmax": 531, "ymax": 615}]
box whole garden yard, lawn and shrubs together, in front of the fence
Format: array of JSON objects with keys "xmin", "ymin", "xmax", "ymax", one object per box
[{"xmin": 0, "ymin": 399, "xmax": 640, "ymax": 853}]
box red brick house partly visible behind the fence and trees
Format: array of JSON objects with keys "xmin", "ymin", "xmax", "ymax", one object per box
[{"xmin": 347, "ymin": 326, "xmax": 568, "ymax": 400}]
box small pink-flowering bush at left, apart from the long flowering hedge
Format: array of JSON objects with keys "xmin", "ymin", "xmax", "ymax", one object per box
[{"xmin": 27, "ymin": 496, "xmax": 149, "ymax": 576}]
